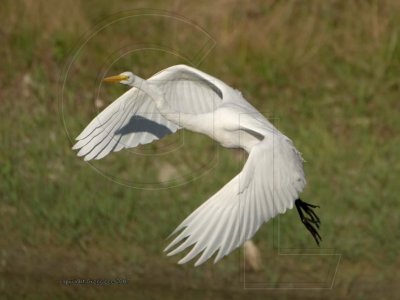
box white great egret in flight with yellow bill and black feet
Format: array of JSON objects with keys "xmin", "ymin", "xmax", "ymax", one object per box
[{"xmin": 73, "ymin": 65, "xmax": 321, "ymax": 266}]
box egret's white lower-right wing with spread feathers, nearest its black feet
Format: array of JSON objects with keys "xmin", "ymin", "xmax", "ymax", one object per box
[{"xmin": 165, "ymin": 134, "xmax": 306, "ymax": 266}]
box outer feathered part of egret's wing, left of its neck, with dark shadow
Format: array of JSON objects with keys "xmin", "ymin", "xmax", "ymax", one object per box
[{"xmin": 72, "ymin": 88, "xmax": 180, "ymax": 160}]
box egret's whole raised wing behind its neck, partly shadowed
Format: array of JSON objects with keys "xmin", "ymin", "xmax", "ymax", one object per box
[{"xmin": 73, "ymin": 65, "xmax": 226, "ymax": 160}]
